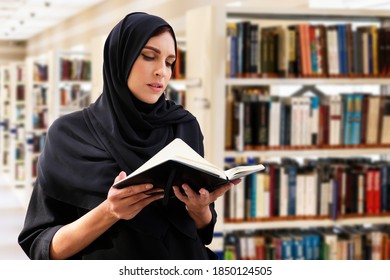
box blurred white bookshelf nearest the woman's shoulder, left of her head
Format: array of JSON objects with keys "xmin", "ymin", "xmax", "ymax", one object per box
[{"xmin": 52, "ymin": 51, "xmax": 92, "ymax": 120}]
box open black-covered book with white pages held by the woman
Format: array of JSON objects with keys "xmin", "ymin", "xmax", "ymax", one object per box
[{"xmin": 114, "ymin": 138, "xmax": 264, "ymax": 203}]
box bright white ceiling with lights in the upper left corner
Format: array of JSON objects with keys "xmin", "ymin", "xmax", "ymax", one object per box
[{"xmin": 0, "ymin": 0, "xmax": 103, "ymax": 40}]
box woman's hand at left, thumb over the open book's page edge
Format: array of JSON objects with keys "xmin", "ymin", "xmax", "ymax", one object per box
[{"xmin": 107, "ymin": 171, "xmax": 164, "ymax": 220}]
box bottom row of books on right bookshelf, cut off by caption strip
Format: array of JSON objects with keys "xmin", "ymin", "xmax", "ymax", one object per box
[{"xmin": 224, "ymin": 226, "xmax": 390, "ymax": 260}]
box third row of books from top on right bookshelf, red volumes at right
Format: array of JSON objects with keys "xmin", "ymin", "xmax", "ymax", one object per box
[{"xmin": 224, "ymin": 158, "xmax": 390, "ymax": 222}]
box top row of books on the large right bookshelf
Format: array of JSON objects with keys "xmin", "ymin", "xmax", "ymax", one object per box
[{"xmin": 226, "ymin": 21, "xmax": 390, "ymax": 77}]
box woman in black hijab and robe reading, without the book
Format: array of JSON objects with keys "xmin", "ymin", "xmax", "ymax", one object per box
[{"xmin": 19, "ymin": 13, "xmax": 238, "ymax": 259}]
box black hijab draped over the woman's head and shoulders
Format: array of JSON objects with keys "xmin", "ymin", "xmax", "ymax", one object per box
[{"xmin": 38, "ymin": 12, "xmax": 203, "ymax": 209}]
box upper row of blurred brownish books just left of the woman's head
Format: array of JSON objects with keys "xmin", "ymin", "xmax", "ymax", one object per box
[{"xmin": 60, "ymin": 58, "xmax": 92, "ymax": 81}]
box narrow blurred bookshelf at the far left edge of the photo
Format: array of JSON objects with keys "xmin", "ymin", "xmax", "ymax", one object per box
[{"xmin": 0, "ymin": 65, "xmax": 11, "ymax": 178}]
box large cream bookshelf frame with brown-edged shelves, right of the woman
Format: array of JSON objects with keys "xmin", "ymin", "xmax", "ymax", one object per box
[{"xmin": 187, "ymin": 5, "xmax": 390, "ymax": 260}]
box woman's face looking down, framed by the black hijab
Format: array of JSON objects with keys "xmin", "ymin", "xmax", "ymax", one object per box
[{"xmin": 127, "ymin": 32, "xmax": 176, "ymax": 104}]
